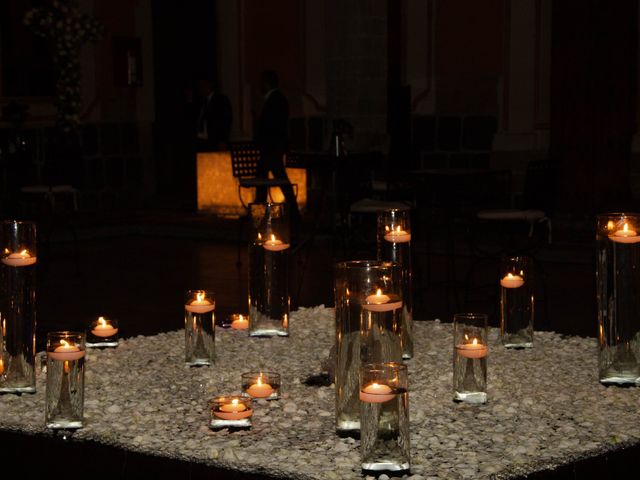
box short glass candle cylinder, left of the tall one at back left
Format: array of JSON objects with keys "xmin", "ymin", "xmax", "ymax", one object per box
[{"xmin": 184, "ymin": 290, "xmax": 216, "ymax": 366}]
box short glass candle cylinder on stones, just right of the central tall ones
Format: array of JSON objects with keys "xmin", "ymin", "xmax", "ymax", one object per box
[{"xmin": 453, "ymin": 313, "xmax": 489, "ymax": 403}]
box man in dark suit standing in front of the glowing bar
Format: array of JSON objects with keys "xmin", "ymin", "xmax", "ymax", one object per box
[{"xmin": 254, "ymin": 71, "xmax": 300, "ymax": 223}]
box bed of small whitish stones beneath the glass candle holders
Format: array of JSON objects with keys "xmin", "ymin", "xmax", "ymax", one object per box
[{"xmin": 0, "ymin": 307, "xmax": 640, "ymax": 479}]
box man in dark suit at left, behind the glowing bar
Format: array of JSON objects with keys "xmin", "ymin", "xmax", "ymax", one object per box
[{"xmin": 196, "ymin": 78, "xmax": 231, "ymax": 152}]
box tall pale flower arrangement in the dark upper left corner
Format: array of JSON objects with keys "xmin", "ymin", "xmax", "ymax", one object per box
[{"xmin": 23, "ymin": 0, "xmax": 103, "ymax": 132}]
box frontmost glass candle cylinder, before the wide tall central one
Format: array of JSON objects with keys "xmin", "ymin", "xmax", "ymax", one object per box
[{"xmin": 359, "ymin": 362, "xmax": 411, "ymax": 476}]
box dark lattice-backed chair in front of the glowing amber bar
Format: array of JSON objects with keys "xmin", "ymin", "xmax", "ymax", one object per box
[{"xmin": 229, "ymin": 142, "xmax": 297, "ymax": 209}]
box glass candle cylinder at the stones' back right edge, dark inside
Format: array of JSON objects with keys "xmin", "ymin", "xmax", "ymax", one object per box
[{"xmin": 500, "ymin": 257, "xmax": 534, "ymax": 348}]
